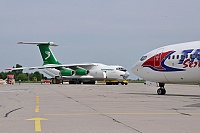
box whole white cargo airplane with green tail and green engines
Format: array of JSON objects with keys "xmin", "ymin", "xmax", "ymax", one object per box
[{"xmin": 6, "ymin": 42, "xmax": 129, "ymax": 85}]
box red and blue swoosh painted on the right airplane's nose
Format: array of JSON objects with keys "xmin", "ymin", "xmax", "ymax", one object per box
[{"xmin": 142, "ymin": 51, "xmax": 185, "ymax": 72}]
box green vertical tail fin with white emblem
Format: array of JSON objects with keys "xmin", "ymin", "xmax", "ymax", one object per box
[{"xmin": 37, "ymin": 44, "xmax": 61, "ymax": 65}]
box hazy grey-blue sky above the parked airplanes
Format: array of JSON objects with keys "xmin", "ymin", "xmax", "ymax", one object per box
[{"xmin": 0, "ymin": 0, "xmax": 200, "ymax": 79}]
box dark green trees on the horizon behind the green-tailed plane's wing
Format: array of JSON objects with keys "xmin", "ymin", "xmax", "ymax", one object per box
[{"xmin": 0, "ymin": 64, "xmax": 47, "ymax": 81}]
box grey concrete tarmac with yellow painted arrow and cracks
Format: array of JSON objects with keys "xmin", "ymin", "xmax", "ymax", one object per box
[{"xmin": 0, "ymin": 83, "xmax": 200, "ymax": 133}]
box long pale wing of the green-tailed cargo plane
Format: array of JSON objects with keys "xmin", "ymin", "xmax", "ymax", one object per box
[{"xmin": 5, "ymin": 63, "xmax": 95, "ymax": 71}]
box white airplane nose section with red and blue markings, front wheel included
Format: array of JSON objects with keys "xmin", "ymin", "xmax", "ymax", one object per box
[{"xmin": 131, "ymin": 41, "xmax": 200, "ymax": 95}]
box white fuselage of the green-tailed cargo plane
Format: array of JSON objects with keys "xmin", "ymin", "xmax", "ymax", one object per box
[{"xmin": 43, "ymin": 63, "xmax": 129, "ymax": 82}]
